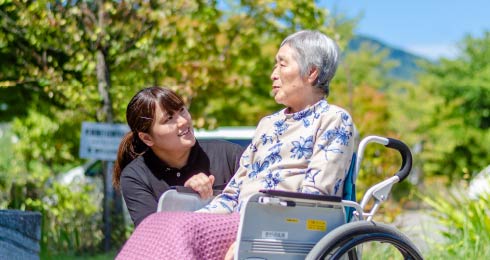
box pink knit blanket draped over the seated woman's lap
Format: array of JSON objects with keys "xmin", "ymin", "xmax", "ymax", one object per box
[{"xmin": 116, "ymin": 212, "xmax": 240, "ymax": 260}]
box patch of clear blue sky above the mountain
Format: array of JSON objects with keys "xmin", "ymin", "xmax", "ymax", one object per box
[{"xmin": 319, "ymin": 0, "xmax": 490, "ymax": 59}]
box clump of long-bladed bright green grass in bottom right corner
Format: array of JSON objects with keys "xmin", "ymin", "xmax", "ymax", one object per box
[{"xmin": 422, "ymin": 190, "xmax": 490, "ymax": 259}]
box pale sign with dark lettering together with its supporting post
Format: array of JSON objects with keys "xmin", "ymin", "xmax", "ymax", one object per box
[{"xmin": 79, "ymin": 122, "xmax": 129, "ymax": 251}]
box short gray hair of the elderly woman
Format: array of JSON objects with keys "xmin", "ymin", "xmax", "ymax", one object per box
[{"xmin": 280, "ymin": 30, "xmax": 339, "ymax": 96}]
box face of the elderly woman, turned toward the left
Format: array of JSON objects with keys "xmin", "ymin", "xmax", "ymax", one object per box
[{"xmin": 271, "ymin": 44, "xmax": 312, "ymax": 113}]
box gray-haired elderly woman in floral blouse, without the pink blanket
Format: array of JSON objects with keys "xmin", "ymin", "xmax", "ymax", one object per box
[{"xmin": 201, "ymin": 31, "xmax": 355, "ymax": 213}]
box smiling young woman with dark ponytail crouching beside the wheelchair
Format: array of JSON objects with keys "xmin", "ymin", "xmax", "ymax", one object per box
[{"xmin": 113, "ymin": 87, "xmax": 243, "ymax": 225}]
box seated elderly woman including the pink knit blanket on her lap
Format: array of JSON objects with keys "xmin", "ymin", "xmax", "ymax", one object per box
[{"xmin": 118, "ymin": 31, "xmax": 357, "ymax": 259}]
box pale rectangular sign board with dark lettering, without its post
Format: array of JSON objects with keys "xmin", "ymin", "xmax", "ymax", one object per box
[{"xmin": 80, "ymin": 122, "xmax": 129, "ymax": 161}]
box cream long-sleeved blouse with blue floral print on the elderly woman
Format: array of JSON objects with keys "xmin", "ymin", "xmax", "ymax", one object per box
[{"xmin": 199, "ymin": 99, "xmax": 357, "ymax": 213}]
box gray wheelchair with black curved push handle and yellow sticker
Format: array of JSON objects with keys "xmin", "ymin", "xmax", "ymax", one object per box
[{"xmin": 157, "ymin": 136, "xmax": 423, "ymax": 259}]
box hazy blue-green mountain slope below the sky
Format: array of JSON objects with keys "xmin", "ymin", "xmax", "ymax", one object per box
[{"xmin": 347, "ymin": 35, "xmax": 430, "ymax": 81}]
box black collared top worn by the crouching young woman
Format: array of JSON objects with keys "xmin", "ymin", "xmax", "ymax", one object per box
[{"xmin": 120, "ymin": 140, "xmax": 244, "ymax": 226}]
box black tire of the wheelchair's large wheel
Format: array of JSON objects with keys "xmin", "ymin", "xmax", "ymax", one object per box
[{"xmin": 306, "ymin": 221, "xmax": 423, "ymax": 260}]
